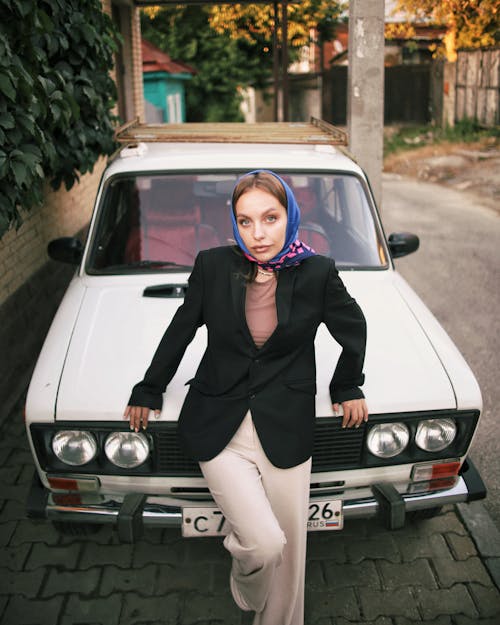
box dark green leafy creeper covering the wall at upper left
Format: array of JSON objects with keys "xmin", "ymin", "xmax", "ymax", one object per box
[{"xmin": 0, "ymin": 0, "xmax": 116, "ymax": 237}]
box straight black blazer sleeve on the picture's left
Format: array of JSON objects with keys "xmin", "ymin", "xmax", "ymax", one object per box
[{"xmin": 129, "ymin": 253, "xmax": 207, "ymax": 410}]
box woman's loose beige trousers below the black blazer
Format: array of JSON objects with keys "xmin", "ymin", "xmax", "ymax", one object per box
[{"xmin": 200, "ymin": 412, "xmax": 311, "ymax": 625}]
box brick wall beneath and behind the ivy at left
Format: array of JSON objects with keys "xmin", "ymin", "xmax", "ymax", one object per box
[{"xmin": 0, "ymin": 0, "xmax": 144, "ymax": 420}]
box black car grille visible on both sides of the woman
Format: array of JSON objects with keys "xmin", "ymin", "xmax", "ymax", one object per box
[{"xmin": 154, "ymin": 418, "xmax": 365, "ymax": 477}]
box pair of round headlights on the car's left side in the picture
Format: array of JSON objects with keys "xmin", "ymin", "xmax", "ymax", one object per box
[{"xmin": 52, "ymin": 430, "xmax": 150, "ymax": 469}]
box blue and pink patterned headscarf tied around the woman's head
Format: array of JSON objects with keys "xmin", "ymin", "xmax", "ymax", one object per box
[{"xmin": 231, "ymin": 169, "xmax": 316, "ymax": 271}]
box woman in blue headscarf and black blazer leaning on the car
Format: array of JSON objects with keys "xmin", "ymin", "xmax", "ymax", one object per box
[{"xmin": 125, "ymin": 170, "xmax": 368, "ymax": 625}]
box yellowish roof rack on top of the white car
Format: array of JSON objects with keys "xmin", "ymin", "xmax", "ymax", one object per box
[{"xmin": 115, "ymin": 117, "xmax": 347, "ymax": 146}]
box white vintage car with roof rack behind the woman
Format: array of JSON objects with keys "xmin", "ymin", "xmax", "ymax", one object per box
[{"xmin": 26, "ymin": 122, "xmax": 485, "ymax": 541}]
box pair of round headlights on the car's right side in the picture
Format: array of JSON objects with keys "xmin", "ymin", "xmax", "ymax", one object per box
[{"xmin": 367, "ymin": 418, "xmax": 457, "ymax": 458}]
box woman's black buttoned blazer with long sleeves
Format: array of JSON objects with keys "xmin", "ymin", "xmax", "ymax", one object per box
[{"xmin": 129, "ymin": 247, "xmax": 366, "ymax": 468}]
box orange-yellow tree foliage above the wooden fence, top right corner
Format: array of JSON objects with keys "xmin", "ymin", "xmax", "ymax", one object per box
[{"xmin": 390, "ymin": 0, "xmax": 500, "ymax": 60}]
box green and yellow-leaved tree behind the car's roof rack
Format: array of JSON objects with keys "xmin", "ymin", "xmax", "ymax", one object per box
[{"xmin": 142, "ymin": 0, "xmax": 341, "ymax": 121}]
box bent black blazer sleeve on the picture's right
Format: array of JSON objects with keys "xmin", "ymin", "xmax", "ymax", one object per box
[{"xmin": 323, "ymin": 260, "xmax": 366, "ymax": 403}]
